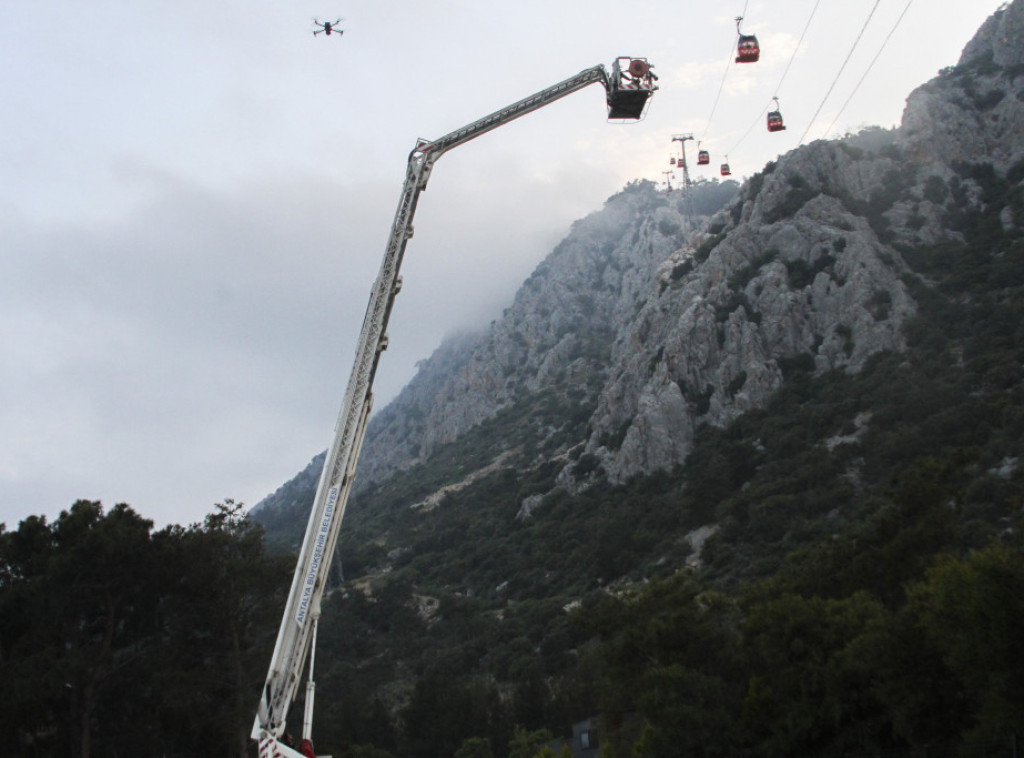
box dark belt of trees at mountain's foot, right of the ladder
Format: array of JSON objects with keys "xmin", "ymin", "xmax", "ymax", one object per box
[{"xmin": 305, "ymin": 467, "xmax": 1024, "ymax": 758}]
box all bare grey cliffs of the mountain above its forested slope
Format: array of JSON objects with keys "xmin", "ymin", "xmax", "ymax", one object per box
[{"xmin": 253, "ymin": 0, "xmax": 1024, "ymax": 517}]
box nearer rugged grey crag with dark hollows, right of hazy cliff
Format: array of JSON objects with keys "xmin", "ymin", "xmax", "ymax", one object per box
[{"xmin": 587, "ymin": 177, "xmax": 914, "ymax": 481}]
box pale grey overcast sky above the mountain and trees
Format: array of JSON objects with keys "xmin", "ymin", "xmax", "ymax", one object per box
[{"xmin": 0, "ymin": 0, "xmax": 1000, "ymax": 529}]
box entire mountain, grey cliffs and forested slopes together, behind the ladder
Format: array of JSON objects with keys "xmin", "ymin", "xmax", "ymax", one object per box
[{"xmin": 250, "ymin": 0, "xmax": 1024, "ymax": 756}]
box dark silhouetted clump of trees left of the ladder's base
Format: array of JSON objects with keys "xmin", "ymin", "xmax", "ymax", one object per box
[{"xmin": 0, "ymin": 501, "xmax": 292, "ymax": 758}]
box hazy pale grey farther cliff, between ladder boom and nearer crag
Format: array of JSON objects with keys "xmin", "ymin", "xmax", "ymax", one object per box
[{"xmin": 356, "ymin": 183, "xmax": 693, "ymax": 488}]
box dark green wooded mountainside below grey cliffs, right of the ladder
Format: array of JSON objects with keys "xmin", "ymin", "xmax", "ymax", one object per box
[{"xmin": 266, "ymin": 156, "xmax": 1024, "ymax": 757}]
